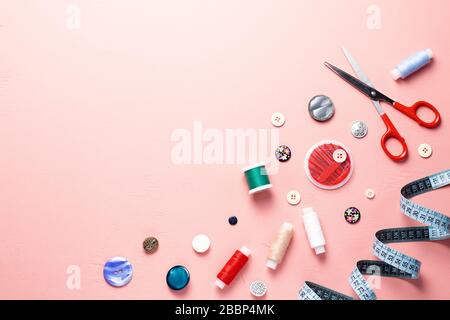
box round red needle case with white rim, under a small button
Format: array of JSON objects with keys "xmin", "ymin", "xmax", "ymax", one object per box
[{"xmin": 305, "ymin": 141, "xmax": 353, "ymax": 190}]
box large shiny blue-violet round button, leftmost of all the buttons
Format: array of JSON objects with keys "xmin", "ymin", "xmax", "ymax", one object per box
[{"xmin": 103, "ymin": 257, "xmax": 133, "ymax": 287}]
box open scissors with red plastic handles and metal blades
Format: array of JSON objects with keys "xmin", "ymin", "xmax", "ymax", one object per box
[{"xmin": 325, "ymin": 47, "xmax": 441, "ymax": 161}]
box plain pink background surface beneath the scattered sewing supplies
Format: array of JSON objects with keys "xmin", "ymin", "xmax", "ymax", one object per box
[{"xmin": 0, "ymin": 0, "xmax": 450, "ymax": 299}]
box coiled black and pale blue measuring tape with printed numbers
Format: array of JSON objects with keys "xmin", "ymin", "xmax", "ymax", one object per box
[{"xmin": 298, "ymin": 170, "xmax": 450, "ymax": 300}]
